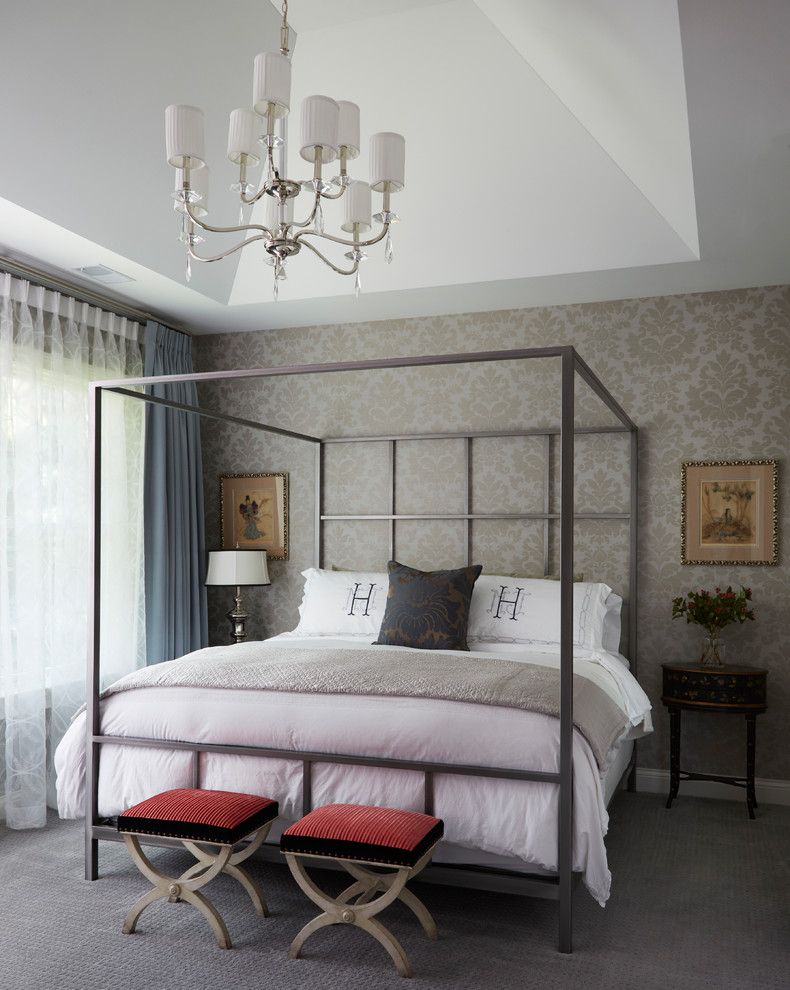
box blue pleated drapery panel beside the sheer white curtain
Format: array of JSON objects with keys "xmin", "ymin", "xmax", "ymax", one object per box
[{"xmin": 145, "ymin": 322, "xmax": 208, "ymax": 664}]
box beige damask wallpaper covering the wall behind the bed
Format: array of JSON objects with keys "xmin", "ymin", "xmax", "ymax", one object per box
[{"xmin": 193, "ymin": 286, "xmax": 790, "ymax": 781}]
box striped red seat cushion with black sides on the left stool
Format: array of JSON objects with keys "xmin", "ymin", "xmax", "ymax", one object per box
[{"xmin": 118, "ymin": 787, "xmax": 279, "ymax": 845}]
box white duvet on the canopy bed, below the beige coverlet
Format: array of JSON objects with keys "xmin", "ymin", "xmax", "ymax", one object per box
[{"xmin": 55, "ymin": 634, "xmax": 651, "ymax": 904}]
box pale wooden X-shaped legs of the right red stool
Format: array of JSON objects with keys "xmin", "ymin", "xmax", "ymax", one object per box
[{"xmin": 285, "ymin": 846, "xmax": 439, "ymax": 977}]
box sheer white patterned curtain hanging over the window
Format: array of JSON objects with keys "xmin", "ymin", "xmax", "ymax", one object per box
[{"xmin": 0, "ymin": 274, "xmax": 145, "ymax": 828}]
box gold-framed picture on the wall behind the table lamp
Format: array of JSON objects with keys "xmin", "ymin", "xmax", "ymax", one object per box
[{"xmin": 219, "ymin": 472, "xmax": 288, "ymax": 560}]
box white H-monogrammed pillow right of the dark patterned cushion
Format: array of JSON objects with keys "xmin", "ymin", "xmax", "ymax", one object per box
[{"xmin": 467, "ymin": 574, "xmax": 622, "ymax": 651}]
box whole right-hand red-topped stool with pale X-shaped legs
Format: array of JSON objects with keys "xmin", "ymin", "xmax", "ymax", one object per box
[{"xmin": 280, "ymin": 804, "xmax": 444, "ymax": 976}]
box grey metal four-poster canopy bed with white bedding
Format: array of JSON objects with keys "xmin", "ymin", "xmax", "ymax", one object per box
[{"xmin": 58, "ymin": 346, "xmax": 650, "ymax": 952}]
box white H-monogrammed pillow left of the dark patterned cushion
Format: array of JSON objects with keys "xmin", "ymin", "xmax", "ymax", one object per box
[{"xmin": 294, "ymin": 567, "xmax": 389, "ymax": 642}]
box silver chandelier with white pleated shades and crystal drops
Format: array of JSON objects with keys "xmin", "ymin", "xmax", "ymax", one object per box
[{"xmin": 165, "ymin": 0, "xmax": 405, "ymax": 300}]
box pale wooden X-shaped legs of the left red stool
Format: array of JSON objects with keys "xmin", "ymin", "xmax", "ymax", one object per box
[{"xmin": 123, "ymin": 822, "xmax": 271, "ymax": 949}]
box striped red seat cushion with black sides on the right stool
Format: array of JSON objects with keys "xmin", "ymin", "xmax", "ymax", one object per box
[{"xmin": 280, "ymin": 804, "xmax": 444, "ymax": 866}]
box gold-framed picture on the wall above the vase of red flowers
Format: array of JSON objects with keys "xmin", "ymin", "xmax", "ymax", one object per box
[{"xmin": 680, "ymin": 461, "xmax": 779, "ymax": 564}]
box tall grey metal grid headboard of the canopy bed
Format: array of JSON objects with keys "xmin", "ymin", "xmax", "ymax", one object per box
[{"xmin": 314, "ymin": 429, "xmax": 630, "ymax": 584}]
